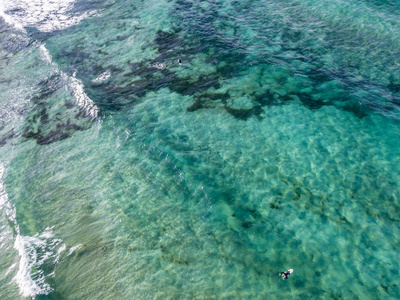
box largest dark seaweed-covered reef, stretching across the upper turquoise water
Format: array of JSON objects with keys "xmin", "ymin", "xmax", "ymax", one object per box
[{"xmin": 39, "ymin": 0, "xmax": 400, "ymax": 120}]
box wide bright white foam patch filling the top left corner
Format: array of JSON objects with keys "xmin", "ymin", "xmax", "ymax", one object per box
[{"xmin": 0, "ymin": 0, "xmax": 96, "ymax": 32}]
